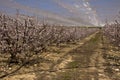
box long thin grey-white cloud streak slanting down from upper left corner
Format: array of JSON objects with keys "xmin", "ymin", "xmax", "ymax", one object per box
[{"xmin": 0, "ymin": 0, "xmax": 82, "ymax": 24}]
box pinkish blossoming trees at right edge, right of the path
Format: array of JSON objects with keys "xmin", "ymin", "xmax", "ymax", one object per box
[{"xmin": 104, "ymin": 20, "xmax": 120, "ymax": 47}]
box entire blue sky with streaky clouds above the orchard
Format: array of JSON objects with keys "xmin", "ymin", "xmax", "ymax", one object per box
[{"xmin": 0, "ymin": 0, "xmax": 120, "ymax": 25}]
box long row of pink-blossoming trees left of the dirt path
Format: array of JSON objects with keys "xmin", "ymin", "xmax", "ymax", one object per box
[{"xmin": 0, "ymin": 14, "xmax": 97, "ymax": 63}]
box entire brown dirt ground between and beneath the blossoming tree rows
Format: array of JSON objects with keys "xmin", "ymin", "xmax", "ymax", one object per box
[{"xmin": 0, "ymin": 32, "xmax": 120, "ymax": 80}]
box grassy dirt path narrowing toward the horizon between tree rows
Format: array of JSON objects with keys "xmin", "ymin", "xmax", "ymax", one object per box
[{"xmin": 55, "ymin": 33, "xmax": 111, "ymax": 80}]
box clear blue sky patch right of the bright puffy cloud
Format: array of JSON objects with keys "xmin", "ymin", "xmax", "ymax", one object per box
[{"xmin": 90, "ymin": 0, "xmax": 120, "ymax": 20}]
